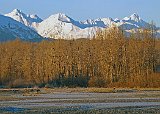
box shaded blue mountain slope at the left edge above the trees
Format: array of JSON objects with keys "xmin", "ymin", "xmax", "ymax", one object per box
[{"xmin": 0, "ymin": 15, "xmax": 42, "ymax": 41}]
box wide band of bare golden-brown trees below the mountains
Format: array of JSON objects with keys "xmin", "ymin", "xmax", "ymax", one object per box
[{"xmin": 0, "ymin": 27, "xmax": 160, "ymax": 87}]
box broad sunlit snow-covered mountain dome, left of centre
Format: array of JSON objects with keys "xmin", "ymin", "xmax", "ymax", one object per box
[{"xmin": 36, "ymin": 13, "xmax": 99, "ymax": 38}]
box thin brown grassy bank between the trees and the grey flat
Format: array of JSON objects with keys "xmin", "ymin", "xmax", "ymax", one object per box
[{"xmin": 0, "ymin": 87, "xmax": 160, "ymax": 93}]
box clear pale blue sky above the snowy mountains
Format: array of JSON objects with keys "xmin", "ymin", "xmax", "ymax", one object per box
[{"xmin": 0, "ymin": 0, "xmax": 160, "ymax": 26}]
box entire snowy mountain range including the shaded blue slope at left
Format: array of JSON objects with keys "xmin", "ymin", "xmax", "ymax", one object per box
[{"xmin": 0, "ymin": 9, "xmax": 159, "ymax": 41}]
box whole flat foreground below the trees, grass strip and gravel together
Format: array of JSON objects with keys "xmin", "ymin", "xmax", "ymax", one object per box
[{"xmin": 0, "ymin": 88, "xmax": 160, "ymax": 114}]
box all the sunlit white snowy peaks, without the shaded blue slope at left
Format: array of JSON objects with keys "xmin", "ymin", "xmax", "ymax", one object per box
[{"xmin": 2, "ymin": 9, "xmax": 160, "ymax": 39}]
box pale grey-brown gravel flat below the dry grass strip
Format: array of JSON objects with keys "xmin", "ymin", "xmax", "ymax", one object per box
[{"xmin": 0, "ymin": 91, "xmax": 160, "ymax": 113}]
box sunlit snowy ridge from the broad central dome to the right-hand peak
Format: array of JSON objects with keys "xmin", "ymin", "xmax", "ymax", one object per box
[{"xmin": 36, "ymin": 13, "xmax": 155, "ymax": 38}]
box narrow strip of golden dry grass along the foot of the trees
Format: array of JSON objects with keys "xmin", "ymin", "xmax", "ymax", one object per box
[{"xmin": 0, "ymin": 87, "xmax": 160, "ymax": 96}]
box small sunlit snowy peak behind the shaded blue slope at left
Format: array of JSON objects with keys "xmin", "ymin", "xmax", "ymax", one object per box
[{"xmin": 5, "ymin": 9, "xmax": 43, "ymax": 28}]
